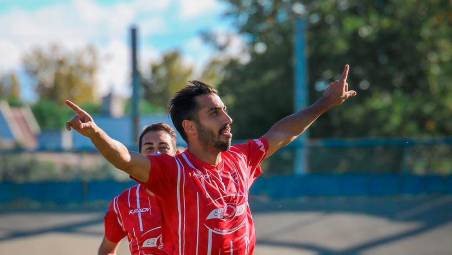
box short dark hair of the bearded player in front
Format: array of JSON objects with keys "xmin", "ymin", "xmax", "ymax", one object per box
[{"xmin": 170, "ymin": 80, "xmax": 218, "ymax": 142}]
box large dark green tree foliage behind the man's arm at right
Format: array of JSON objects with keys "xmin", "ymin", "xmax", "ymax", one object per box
[{"xmin": 214, "ymin": 0, "xmax": 452, "ymax": 138}]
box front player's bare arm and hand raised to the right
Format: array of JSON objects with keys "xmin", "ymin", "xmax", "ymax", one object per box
[{"xmin": 264, "ymin": 65, "xmax": 356, "ymax": 158}]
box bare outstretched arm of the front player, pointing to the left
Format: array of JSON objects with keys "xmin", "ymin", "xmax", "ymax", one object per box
[{"xmin": 65, "ymin": 100, "xmax": 151, "ymax": 182}]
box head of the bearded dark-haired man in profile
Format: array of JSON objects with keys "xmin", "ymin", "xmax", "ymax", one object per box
[{"xmin": 170, "ymin": 81, "xmax": 232, "ymax": 151}]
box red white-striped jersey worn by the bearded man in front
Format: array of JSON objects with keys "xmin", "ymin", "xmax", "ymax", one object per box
[{"xmin": 145, "ymin": 139, "xmax": 268, "ymax": 255}]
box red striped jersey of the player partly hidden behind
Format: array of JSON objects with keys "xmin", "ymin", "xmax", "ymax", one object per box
[{"xmin": 104, "ymin": 184, "xmax": 166, "ymax": 255}]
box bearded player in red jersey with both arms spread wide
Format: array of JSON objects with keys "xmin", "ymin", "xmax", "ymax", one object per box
[{"xmin": 67, "ymin": 65, "xmax": 356, "ymax": 254}]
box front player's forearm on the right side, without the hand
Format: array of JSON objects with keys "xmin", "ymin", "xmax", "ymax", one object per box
[{"xmin": 264, "ymin": 97, "xmax": 331, "ymax": 157}]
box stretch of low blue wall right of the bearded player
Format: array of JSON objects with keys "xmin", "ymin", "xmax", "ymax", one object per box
[{"xmin": 252, "ymin": 174, "xmax": 452, "ymax": 199}]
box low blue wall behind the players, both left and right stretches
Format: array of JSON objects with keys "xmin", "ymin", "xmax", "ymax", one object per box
[{"xmin": 0, "ymin": 174, "xmax": 452, "ymax": 204}]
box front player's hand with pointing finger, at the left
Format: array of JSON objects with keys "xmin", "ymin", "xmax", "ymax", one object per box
[{"xmin": 64, "ymin": 100, "xmax": 98, "ymax": 137}]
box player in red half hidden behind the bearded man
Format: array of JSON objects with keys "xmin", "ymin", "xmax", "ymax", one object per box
[{"xmin": 97, "ymin": 123, "xmax": 177, "ymax": 255}]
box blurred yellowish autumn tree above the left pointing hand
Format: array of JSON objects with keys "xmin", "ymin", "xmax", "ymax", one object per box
[{"xmin": 23, "ymin": 45, "xmax": 98, "ymax": 104}]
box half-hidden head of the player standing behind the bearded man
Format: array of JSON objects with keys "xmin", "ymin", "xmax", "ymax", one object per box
[{"xmin": 138, "ymin": 123, "xmax": 177, "ymax": 156}]
